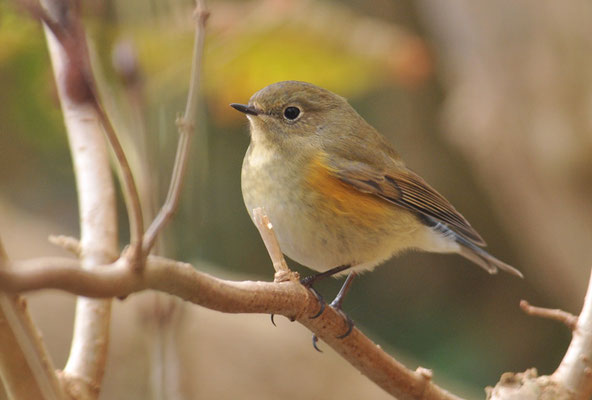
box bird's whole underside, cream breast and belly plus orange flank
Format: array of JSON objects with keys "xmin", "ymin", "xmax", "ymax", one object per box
[{"xmin": 242, "ymin": 144, "xmax": 418, "ymax": 271}]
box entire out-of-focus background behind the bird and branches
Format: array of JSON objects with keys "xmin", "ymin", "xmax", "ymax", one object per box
[{"xmin": 0, "ymin": 0, "xmax": 592, "ymax": 399}]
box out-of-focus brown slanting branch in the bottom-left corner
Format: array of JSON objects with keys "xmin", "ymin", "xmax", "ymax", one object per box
[{"xmin": 0, "ymin": 242, "xmax": 63, "ymax": 400}]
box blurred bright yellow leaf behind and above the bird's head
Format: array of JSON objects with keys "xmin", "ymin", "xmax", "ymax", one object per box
[{"xmin": 130, "ymin": 27, "xmax": 377, "ymax": 109}]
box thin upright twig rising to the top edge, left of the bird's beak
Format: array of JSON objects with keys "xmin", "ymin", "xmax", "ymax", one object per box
[{"xmin": 142, "ymin": 0, "xmax": 209, "ymax": 254}]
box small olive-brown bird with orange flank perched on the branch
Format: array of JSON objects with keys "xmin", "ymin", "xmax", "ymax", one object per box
[{"xmin": 231, "ymin": 81, "xmax": 522, "ymax": 348}]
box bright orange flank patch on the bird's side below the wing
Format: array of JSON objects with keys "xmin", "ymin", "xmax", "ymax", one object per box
[{"xmin": 305, "ymin": 154, "xmax": 395, "ymax": 225}]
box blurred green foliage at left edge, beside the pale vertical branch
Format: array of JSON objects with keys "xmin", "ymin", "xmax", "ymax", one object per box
[{"xmin": 0, "ymin": 2, "xmax": 76, "ymax": 223}]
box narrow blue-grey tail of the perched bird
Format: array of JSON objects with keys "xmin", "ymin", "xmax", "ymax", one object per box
[{"xmin": 424, "ymin": 217, "xmax": 524, "ymax": 278}]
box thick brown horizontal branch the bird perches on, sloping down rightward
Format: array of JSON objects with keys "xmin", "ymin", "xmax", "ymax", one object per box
[{"xmin": 0, "ymin": 256, "xmax": 459, "ymax": 400}]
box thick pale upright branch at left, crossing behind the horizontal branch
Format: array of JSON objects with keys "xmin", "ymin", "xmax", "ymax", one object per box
[{"xmin": 44, "ymin": 0, "xmax": 118, "ymax": 398}]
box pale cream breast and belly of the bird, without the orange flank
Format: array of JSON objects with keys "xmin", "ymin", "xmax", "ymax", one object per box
[{"xmin": 242, "ymin": 145, "xmax": 425, "ymax": 271}]
